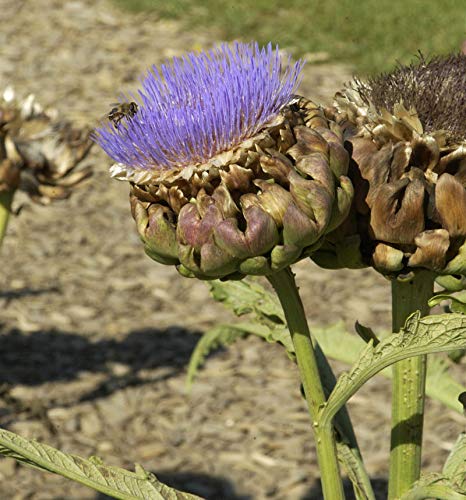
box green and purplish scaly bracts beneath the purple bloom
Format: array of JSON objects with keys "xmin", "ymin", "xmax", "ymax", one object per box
[{"xmin": 131, "ymin": 98, "xmax": 353, "ymax": 279}]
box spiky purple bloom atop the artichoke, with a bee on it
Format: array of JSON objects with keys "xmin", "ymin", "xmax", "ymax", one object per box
[{"xmin": 94, "ymin": 43, "xmax": 304, "ymax": 171}]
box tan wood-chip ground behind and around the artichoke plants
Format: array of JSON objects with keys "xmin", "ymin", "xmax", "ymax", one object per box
[{"xmin": 0, "ymin": 0, "xmax": 464, "ymax": 500}]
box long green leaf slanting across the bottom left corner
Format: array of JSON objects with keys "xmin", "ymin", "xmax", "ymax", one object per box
[{"xmin": 0, "ymin": 429, "xmax": 200, "ymax": 500}]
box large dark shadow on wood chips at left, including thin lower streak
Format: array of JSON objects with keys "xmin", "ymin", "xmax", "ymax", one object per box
[{"xmin": 0, "ymin": 326, "xmax": 209, "ymax": 416}]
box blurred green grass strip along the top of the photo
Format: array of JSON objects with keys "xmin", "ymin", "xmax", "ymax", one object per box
[{"xmin": 114, "ymin": 0, "xmax": 466, "ymax": 74}]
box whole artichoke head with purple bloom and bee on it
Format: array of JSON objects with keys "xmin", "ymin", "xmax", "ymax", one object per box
[{"xmin": 94, "ymin": 43, "xmax": 352, "ymax": 279}]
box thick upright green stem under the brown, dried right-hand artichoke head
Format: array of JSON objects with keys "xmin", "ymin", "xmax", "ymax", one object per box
[{"xmin": 388, "ymin": 271, "xmax": 434, "ymax": 499}]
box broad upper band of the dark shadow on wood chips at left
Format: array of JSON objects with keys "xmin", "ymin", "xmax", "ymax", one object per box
[{"xmin": 0, "ymin": 326, "xmax": 201, "ymax": 386}]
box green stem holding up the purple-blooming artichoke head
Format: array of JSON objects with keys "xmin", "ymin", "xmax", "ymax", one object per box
[{"xmin": 268, "ymin": 268, "xmax": 344, "ymax": 500}]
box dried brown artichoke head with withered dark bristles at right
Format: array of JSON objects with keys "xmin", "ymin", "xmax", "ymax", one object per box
[{"xmin": 314, "ymin": 54, "xmax": 466, "ymax": 282}]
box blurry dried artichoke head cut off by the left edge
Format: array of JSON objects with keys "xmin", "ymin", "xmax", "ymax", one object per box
[{"xmin": 0, "ymin": 87, "xmax": 92, "ymax": 205}]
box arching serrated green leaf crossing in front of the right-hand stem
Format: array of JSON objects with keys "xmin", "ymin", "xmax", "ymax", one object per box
[{"xmin": 319, "ymin": 312, "xmax": 466, "ymax": 425}]
